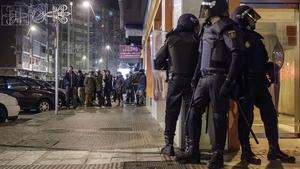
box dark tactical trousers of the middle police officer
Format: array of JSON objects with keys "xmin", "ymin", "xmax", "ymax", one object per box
[{"xmin": 186, "ymin": 75, "xmax": 229, "ymax": 151}]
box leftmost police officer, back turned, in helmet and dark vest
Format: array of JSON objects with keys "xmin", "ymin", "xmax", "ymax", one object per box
[{"xmin": 154, "ymin": 14, "xmax": 200, "ymax": 156}]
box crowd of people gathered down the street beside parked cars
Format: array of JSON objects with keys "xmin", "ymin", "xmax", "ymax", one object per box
[{"xmin": 63, "ymin": 66, "xmax": 146, "ymax": 108}]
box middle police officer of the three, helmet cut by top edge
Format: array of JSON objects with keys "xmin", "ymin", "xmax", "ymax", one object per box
[{"xmin": 176, "ymin": 0, "xmax": 243, "ymax": 169}]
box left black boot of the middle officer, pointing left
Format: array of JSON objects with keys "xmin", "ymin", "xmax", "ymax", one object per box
[{"xmin": 175, "ymin": 141, "xmax": 200, "ymax": 164}]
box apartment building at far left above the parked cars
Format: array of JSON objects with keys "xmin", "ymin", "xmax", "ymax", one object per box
[{"xmin": 0, "ymin": 0, "xmax": 55, "ymax": 80}]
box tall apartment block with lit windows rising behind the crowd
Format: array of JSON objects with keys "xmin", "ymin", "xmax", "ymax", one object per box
[{"xmin": 59, "ymin": 0, "xmax": 124, "ymax": 75}]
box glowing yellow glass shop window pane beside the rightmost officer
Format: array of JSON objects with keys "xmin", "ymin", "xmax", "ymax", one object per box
[{"xmin": 255, "ymin": 8, "xmax": 299, "ymax": 133}]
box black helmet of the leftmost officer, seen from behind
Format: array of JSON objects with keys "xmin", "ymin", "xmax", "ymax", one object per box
[{"xmin": 177, "ymin": 13, "xmax": 200, "ymax": 32}]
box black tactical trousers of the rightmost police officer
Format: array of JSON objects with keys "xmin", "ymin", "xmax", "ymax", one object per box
[{"xmin": 238, "ymin": 75, "xmax": 278, "ymax": 145}]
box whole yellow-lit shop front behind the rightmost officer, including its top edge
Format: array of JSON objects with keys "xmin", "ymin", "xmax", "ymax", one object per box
[{"xmin": 241, "ymin": 0, "xmax": 300, "ymax": 138}]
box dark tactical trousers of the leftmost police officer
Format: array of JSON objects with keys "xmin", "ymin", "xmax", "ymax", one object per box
[{"xmin": 165, "ymin": 76, "xmax": 192, "ymax": 138}]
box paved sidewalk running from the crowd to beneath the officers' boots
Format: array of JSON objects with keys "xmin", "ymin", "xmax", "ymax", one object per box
[{"xmin": 0, "ymin": 107, "xmax": 300, "ymax": 169}]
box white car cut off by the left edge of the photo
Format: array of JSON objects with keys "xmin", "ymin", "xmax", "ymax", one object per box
[{"xmin": 0, "ymin": 93, "xmax": 20, "ymax": 123}]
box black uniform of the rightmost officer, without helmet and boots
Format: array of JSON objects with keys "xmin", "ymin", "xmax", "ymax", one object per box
[{"xmin": 239, "ymin": 29, "xmax": 278, "ymax": 150}]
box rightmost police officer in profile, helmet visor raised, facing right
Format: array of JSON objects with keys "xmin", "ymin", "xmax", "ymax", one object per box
[{"xmin": 232, "ymin": 6, "xmax": 295, "ymax": 164}]
